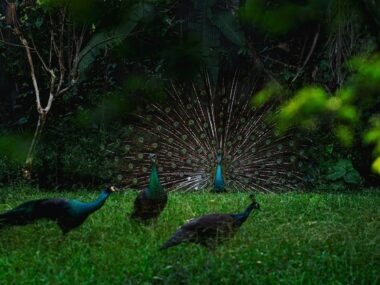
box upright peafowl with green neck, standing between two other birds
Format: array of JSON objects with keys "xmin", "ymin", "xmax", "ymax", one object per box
[{"xmin": 131, "ymin": 155, "xmax": 168, "ymax": 220}]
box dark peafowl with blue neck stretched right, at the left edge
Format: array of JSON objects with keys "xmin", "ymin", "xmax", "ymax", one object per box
[{"xmin": 0, "ymin": 186, "xmax": 116, "ymax": 234}]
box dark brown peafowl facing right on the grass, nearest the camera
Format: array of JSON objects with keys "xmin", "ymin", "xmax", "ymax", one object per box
[{"xmin": 160, "ymin": 193, "xmax": 260, "ymax": 250}]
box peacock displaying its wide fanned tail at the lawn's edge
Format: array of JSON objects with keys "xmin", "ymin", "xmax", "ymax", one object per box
[{"xmin": 113, "ymin": 74, "xmax": 306, "ymax": 192}]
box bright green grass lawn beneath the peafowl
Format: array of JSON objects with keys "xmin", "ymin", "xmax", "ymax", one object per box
[{"xmin": 0, "ymin": 188, "xmax": 380, "ymax": 285}]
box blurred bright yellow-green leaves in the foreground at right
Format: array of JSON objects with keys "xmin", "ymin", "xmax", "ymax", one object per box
[{"xmin": 270, "ymin": 52, "xmax": 380, "ymax": 175}]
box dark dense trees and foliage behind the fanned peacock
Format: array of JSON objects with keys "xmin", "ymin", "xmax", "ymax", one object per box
[{"xmin": 0, "ymin": 0, "xmax": 380, "ymax": 190}]
